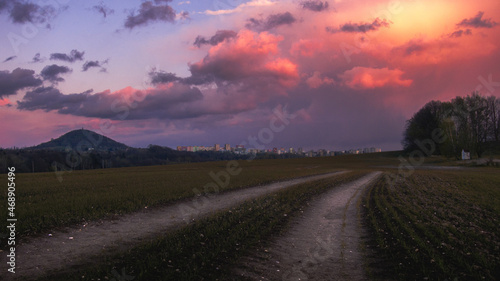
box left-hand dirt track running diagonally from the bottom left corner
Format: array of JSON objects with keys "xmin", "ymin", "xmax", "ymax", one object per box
[{"xmin": 0, "ymin": 172, "xmax": 342, "ymax": 280}]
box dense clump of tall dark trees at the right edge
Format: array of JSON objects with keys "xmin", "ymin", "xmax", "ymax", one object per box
[{"xmin": 402, "ymin": 92, "xmax": 500, "ymax": 159}]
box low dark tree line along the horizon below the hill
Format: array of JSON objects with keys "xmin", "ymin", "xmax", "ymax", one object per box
[{"xmin": 0, "ymin": 145, "xmax": 300, "ymax": 173}]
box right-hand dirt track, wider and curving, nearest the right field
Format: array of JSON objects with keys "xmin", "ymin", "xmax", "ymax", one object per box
[{"xmin": 234, "ymin": 172, "xmax": 381, "ymax": 280}]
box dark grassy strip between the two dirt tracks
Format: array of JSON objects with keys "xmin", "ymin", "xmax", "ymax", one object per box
[{"xmin": 40, "ymin": 171, "xmax": 366, "ymax": 281}]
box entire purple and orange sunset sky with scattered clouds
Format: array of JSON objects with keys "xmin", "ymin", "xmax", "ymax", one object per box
[{"xmin": 0, "ymin": 0, "xmax": 500, "ymax": 150}]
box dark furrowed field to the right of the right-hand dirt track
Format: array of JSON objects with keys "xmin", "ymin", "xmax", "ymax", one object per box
[{"xmin": 363, "ymin": 168, "xmax": 500, "ymax": 280}]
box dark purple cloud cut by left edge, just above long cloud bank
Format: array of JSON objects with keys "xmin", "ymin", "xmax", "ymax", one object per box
[{"xmin": 0, "ymin": 68, "xmax": 42, "ymax": 98}]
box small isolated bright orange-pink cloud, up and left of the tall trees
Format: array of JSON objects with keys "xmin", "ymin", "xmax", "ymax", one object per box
[{"xmin": 341, "ymin": 66, "xmax": 413, "ymax": 89}]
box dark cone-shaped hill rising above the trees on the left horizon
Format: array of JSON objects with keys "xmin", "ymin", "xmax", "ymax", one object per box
[{"xmin": 31, "ymin": 129, "xmax": 128, "ymax": 151}]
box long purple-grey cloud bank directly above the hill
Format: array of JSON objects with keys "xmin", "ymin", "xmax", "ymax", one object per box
[{"xmin": 17, "ymin": 84, "xmax": 206, "ymax": 120}]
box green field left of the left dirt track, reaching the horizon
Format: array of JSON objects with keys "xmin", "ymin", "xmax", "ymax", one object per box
[{"xmin": 0, "ymin": 153, "xmax": 402, "ymax": 236}]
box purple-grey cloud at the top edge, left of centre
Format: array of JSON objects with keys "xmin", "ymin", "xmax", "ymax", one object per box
[{"xmin": 124, "ymin": 0, "xmax": 176, "ymax": 29}]
